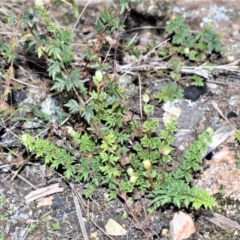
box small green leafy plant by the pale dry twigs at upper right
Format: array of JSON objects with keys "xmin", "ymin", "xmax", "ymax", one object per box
[{"xmin": 160, "ymin": 16, "xmax": 223, "ymax": 86}]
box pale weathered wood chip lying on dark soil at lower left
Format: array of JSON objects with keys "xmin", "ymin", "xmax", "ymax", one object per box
[{"xmin": 25, "ymin": 183, "xmax": 64, "ymax": 204}]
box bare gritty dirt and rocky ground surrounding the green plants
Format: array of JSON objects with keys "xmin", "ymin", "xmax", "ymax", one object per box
[{"xmin": 0, "ymin": 0, "xmax": 240, "ymax": 240}]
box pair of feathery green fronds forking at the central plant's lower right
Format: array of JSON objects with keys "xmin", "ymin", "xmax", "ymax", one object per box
[{"xmin": 149, "ymin": 130, "xmax": 216, "ymax": 209}]
